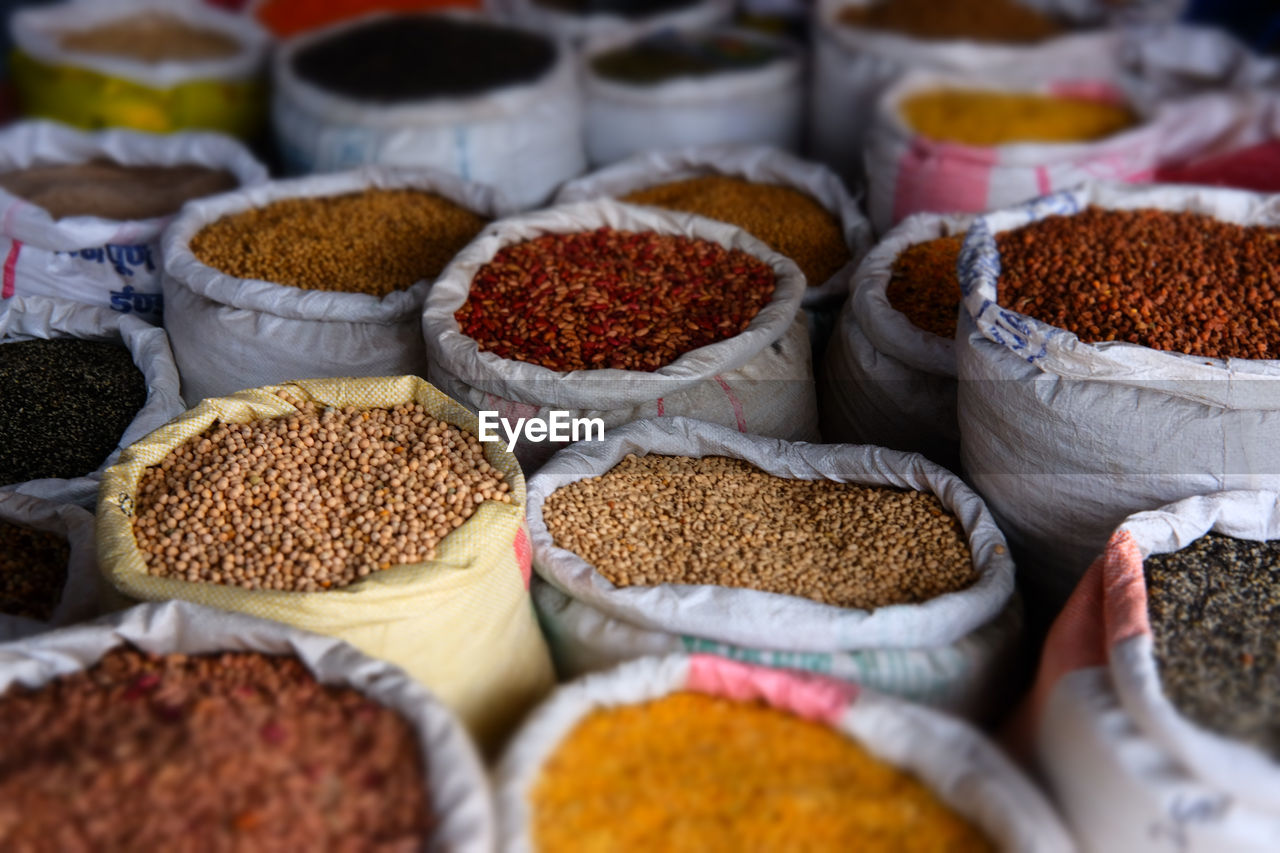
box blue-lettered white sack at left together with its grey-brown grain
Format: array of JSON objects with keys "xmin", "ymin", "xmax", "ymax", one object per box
[{"xmin": 0, "ymin": 122, "xmax": 266, "ymax": 323}]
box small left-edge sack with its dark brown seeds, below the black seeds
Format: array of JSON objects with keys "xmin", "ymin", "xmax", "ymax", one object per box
[{"xmin": 0, "ymin": 492, "xmax": 99, "ymax": 642}]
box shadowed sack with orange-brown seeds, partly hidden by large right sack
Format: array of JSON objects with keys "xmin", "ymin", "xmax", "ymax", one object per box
[{"xmin": 818, "ymin": 214, "xmax": 973, "ymax": 470}]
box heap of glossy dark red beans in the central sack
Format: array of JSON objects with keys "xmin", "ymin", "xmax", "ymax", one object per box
[{"xmin": 454, "ymin": 228, "xmax": 776, "ymax": 371}]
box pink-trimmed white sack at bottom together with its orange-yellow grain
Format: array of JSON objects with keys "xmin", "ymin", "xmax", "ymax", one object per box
[{"xmin": 497, "ymin": 654, "xmax": 1073, "ymax": 853}]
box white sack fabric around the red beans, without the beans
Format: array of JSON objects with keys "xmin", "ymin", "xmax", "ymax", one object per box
[{"xmin": 422, "ymin": 199, "xmax": 818, "ymax": 475}]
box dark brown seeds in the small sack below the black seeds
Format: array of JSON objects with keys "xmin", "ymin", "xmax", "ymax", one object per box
[{"xmin": 0, "ymin": 521, "xmax": 70, "ymax": 622}]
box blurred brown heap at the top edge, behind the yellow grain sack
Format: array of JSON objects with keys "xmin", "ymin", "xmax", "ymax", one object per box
[{"xmin": 840, "ymin": 0, "xmax": 1065, "ymax": 44}]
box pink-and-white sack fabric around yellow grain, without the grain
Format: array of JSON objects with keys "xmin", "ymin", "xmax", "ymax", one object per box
[{"xmin": 865, "ymin": 68, "xmax": 1233, "ymax": 233}]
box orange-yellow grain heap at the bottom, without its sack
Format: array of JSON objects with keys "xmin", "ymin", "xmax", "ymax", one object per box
[{"xmin": 530, "ymin": 693, "xmax": 995, "ymax": 853}]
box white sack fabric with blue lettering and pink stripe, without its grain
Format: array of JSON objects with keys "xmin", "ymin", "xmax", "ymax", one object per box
[{"xmin": 0, "ymin": 122, "xmax": 268, "ymax": 324}]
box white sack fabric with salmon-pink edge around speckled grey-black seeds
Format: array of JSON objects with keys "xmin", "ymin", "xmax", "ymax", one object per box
[{"xmin": 1011, "ymin": 492, "xmax": 1280, "ymax": 852}]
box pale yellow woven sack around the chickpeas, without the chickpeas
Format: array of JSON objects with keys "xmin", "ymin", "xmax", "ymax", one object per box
[{"xmin": 97, "ymin": 377, "xmax": 554, "ymax": 748}]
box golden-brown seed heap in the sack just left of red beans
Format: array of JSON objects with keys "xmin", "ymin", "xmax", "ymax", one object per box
[{"xmin": 191, "ymin": 190, "xmax": 488, "ymax": 296}]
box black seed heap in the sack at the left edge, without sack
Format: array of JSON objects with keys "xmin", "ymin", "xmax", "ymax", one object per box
[{"xmin": 0, "ymin": 338, "xmax": 147, "ymax": 485}]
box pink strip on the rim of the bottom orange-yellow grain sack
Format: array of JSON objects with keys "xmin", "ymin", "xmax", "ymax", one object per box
[{"xmin": 686, "ymin": 654, "xmax": 858, "ymax": 724}]
